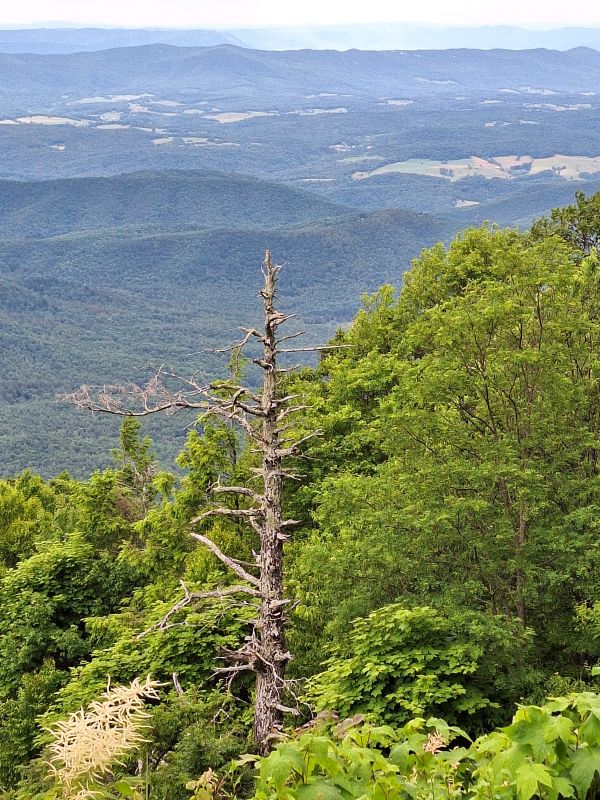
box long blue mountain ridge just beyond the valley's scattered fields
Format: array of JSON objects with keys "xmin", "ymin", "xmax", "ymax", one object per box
[{"xmin": 0, "ymin": 44, "xmax": 600, "ymax": 107}]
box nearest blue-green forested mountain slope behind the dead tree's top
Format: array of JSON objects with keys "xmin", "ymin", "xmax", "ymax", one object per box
[{"xmin": 0, "ymin": 173, "xmax": 449, "ymax": 474}]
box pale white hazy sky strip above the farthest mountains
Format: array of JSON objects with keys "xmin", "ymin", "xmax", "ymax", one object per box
[{"xmin": 0, "ymin": 0, "xmax": 600, "ymax": 28}]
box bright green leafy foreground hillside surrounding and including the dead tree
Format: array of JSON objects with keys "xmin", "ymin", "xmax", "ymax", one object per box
[{"xmin": 0, "ymin": 194, "xmax": 600, "ymax": 800}]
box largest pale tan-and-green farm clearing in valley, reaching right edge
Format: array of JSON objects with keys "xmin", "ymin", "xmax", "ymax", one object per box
[{"xmin": 352, "ymin": 154, "xmax": 600, "ymax": 181}]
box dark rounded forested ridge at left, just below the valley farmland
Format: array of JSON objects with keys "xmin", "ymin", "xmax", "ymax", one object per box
[{"xmin": 0, "ymin": 170, "xmax": 348, "ymax": 238}]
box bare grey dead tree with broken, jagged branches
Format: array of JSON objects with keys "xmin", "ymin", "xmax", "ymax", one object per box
[{"xmin": 62, "ymin": 251, "xmax": 330, "ymax": 754}]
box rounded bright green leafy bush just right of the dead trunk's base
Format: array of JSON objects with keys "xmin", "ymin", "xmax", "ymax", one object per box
[{"xmin": 307, "ymin": 605, "xmax": 528, "ymax": 728}]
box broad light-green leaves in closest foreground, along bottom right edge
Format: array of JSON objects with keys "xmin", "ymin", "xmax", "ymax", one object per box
[{"xmin": 254, "ymin": 693, "xmax": 600, "ymax": 800}]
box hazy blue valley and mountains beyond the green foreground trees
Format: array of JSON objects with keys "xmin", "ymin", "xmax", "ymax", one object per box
[{"xmin": 0, "ymin": 29, "xmax": 600, "ymax": 473}]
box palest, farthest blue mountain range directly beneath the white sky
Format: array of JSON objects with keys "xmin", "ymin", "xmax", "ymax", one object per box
[{"xmin": 0, "ymin": 23, "xmax": 600, "ymax": 54}]
